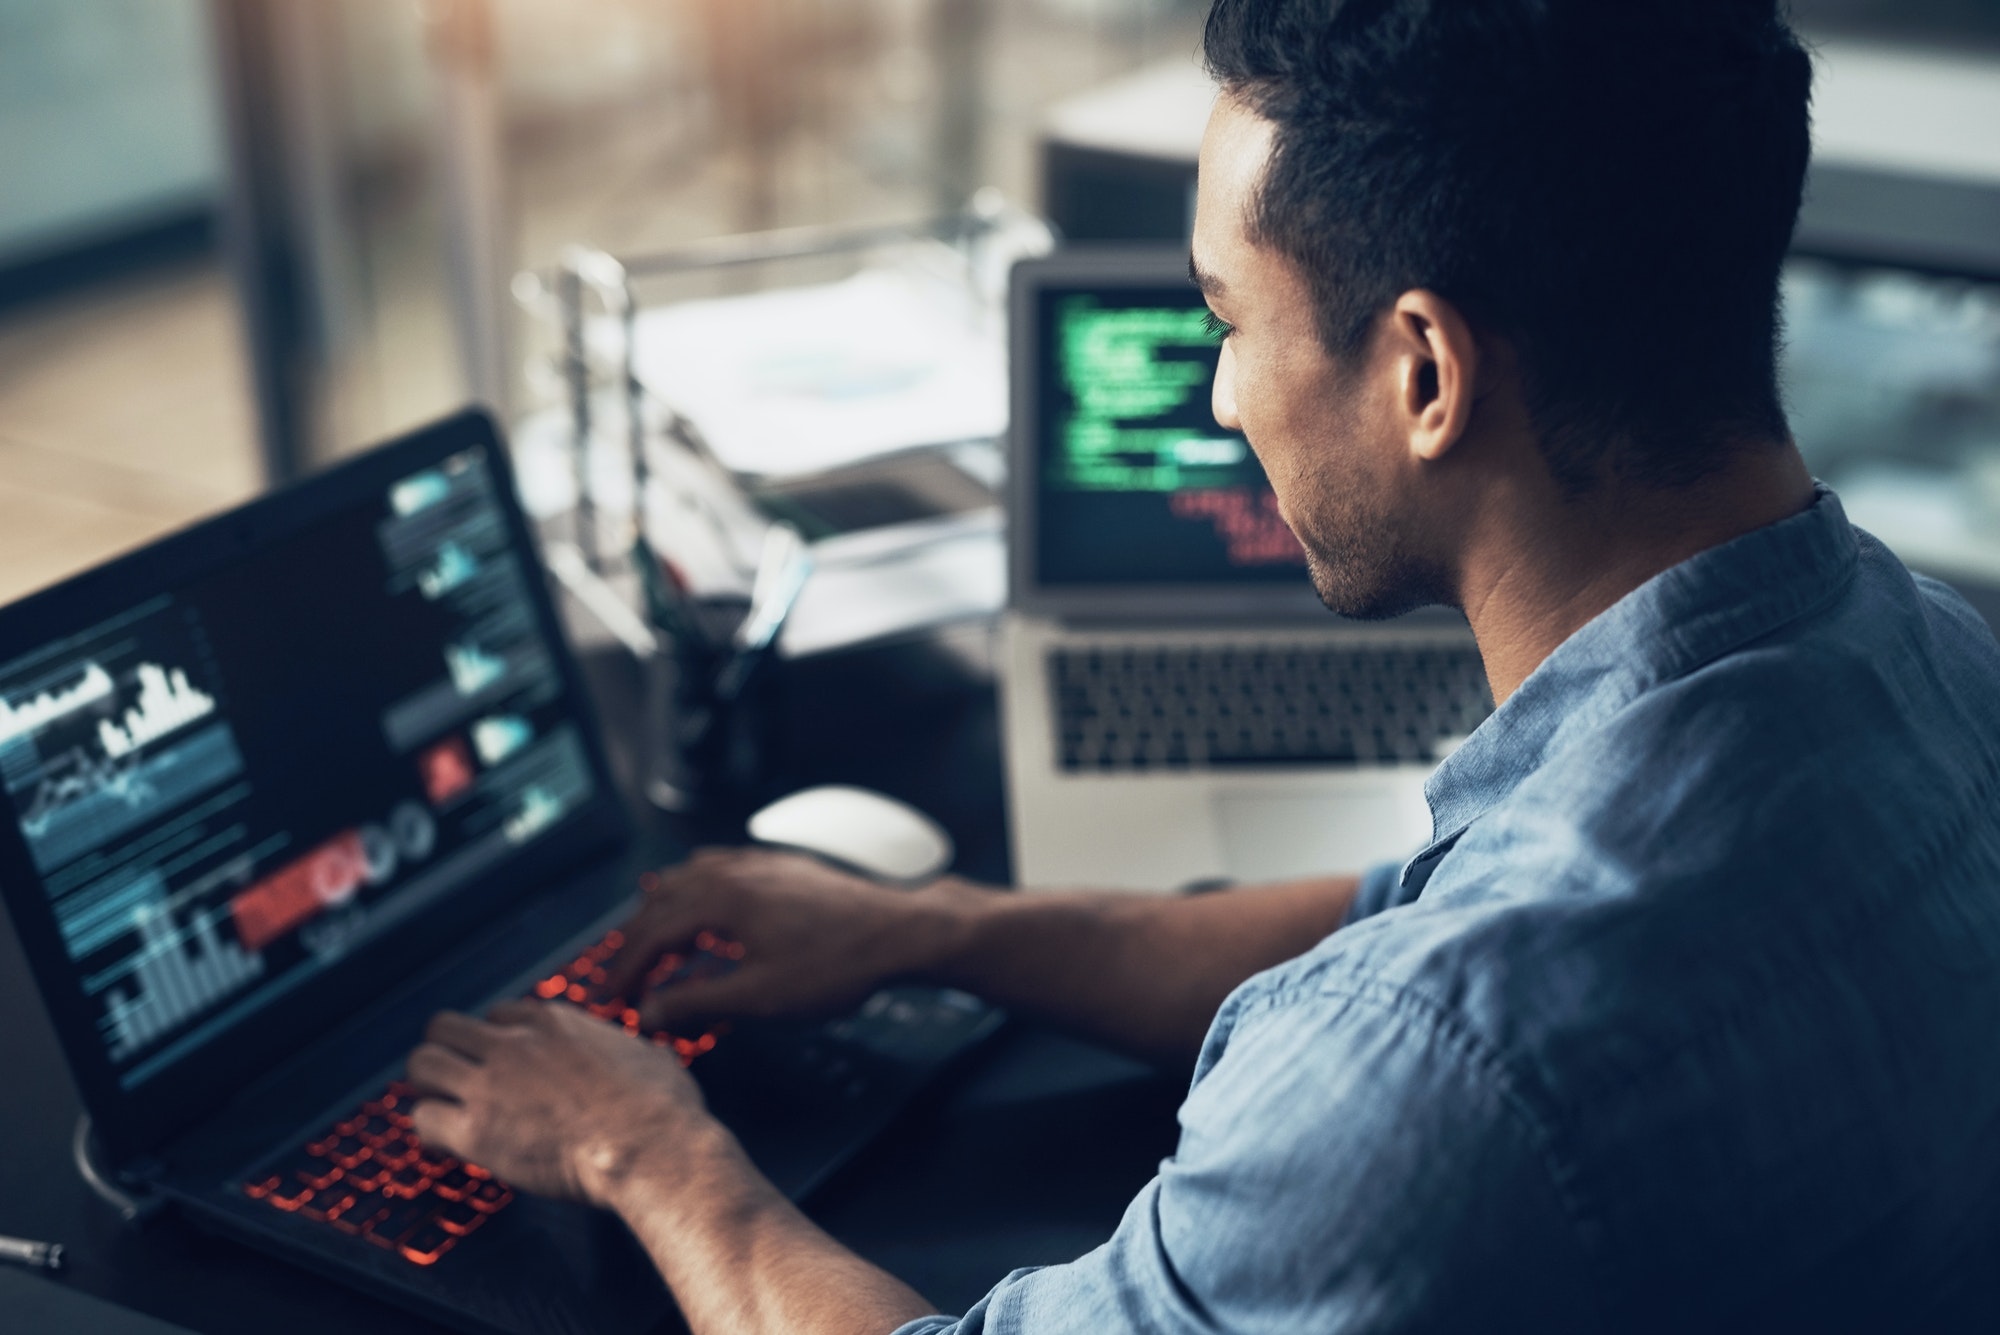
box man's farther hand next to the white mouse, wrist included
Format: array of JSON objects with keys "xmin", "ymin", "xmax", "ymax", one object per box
[{"xmin": 606, "ymin": 849, "xmax": 950, "ymax": 1029}]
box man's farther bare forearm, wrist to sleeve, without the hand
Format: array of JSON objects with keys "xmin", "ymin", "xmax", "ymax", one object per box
[{"xmin": 920, "ymin": 877, "xmax": 1358, "ymax": 1061}]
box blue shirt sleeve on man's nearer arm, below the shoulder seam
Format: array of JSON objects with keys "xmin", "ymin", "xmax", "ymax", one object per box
[{"xmin": 896, "ymin": 987, "xmax": 1594, "ymax": 1335}]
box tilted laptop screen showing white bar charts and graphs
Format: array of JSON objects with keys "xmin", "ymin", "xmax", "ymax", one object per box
[{"xmin": 0, "ymin": 436, "xmax": 600, "ymax": 1093}]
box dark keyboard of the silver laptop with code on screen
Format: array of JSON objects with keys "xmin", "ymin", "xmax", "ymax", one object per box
[{"xmin": 1048, "ymin": 644, "xmax": 1494, "ymax": 771}]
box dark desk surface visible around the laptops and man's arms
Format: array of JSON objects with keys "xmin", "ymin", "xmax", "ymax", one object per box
[{"xmin": 0, "ymin": 628, "xmax": 1184, "ymax": 1335}]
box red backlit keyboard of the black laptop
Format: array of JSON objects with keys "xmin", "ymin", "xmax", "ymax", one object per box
[{"xmin": 244, "ymin": 931, "xmax": 742, "ymax": 1265}]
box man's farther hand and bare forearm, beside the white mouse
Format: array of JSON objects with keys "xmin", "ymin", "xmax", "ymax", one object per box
[{"xmin": 604, "ymin": 849, "xmax": 1356, "ymax": 1065}]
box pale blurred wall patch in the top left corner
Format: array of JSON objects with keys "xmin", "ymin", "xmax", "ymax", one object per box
[{"xmin": 0, "ymin": 0, "xmax": 222, "ymax": 264}]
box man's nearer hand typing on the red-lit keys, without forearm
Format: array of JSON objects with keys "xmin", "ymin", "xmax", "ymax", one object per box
[{"xmin": 410, "ymin": 1001, "xmax": 726, "ymax": 1205}]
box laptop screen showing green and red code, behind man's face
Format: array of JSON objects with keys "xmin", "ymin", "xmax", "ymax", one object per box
[{"xmin": 1034, "ymin": 281, "xmax": 1306, "ymax": 588}]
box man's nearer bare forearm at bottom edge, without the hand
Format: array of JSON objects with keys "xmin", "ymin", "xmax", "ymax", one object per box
[{"xmin": 590, "ymin": 1123, "xmax": 936, "ymax": 1335}]
